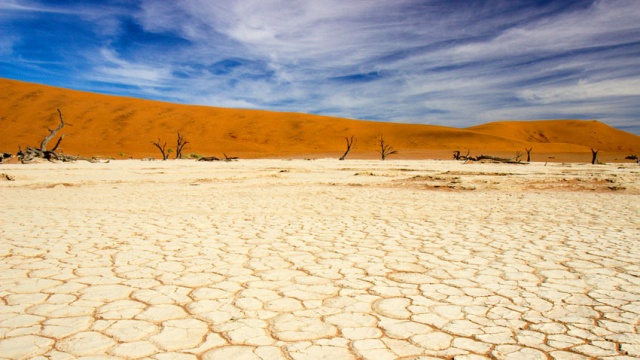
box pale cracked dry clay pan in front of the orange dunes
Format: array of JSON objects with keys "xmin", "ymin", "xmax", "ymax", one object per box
[{"xmin": 0, "ymin": 160, "xmax": 640, "ymax": 360}]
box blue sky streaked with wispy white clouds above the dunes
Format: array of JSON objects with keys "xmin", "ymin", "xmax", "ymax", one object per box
[{"xmin": 0, "ymin": 0, "xmax": 640, "ymax": 134}]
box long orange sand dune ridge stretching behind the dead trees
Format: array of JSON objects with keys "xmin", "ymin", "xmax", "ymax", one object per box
[{"xmin": 0, "ymin": 79, "xmax": 640, "ymax": 161}]
